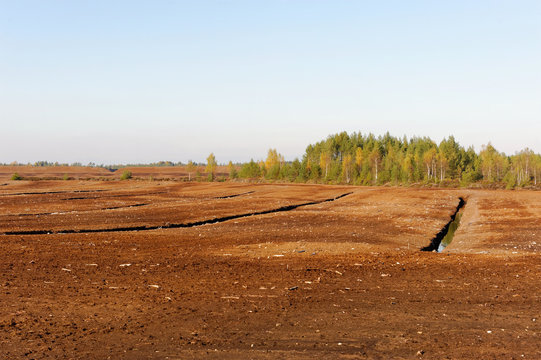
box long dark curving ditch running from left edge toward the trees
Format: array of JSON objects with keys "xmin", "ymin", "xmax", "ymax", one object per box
[{"xmin": 0, "ymin": 192, "xmax": 353, "ymax": 235}]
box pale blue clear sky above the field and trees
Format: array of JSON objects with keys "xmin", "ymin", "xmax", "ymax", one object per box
[{"xmin": 0, "ymin": 0, "xmax": 541, "ymax": 164}]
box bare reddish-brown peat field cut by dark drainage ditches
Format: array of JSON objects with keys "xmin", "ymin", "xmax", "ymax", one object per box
[{"xmin": 0, "ymin": 180, "xmax": 541, "ymax": 359}]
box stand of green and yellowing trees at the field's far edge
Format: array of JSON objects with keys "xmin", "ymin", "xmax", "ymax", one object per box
[{"xmin": 231, "ymin": 132, "xmax": 541, "ymax": 188}]
